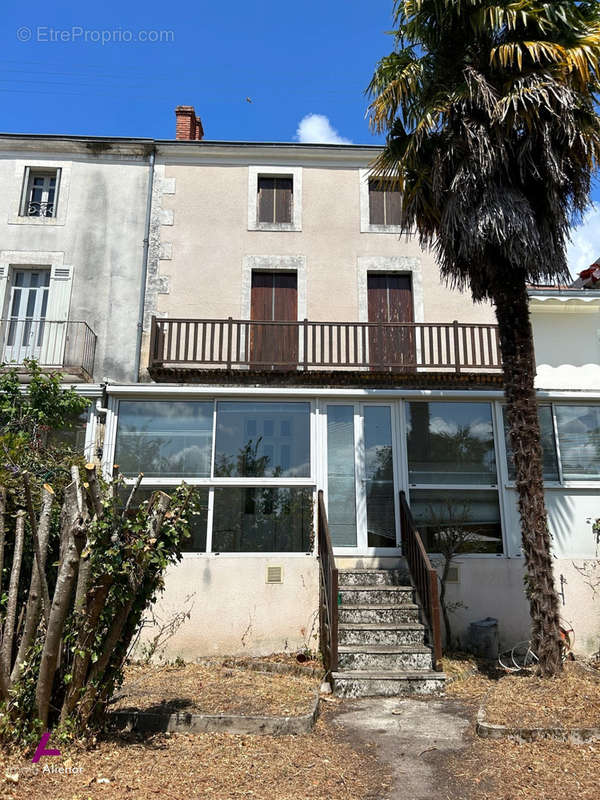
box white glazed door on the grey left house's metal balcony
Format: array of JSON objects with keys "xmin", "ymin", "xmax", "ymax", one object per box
[{"xmin": 3, "ymin": 269, "xmax": 50, "ymax": 364}]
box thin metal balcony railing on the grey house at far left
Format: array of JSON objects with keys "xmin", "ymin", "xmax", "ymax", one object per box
[{"xmin": 0, "ymin": 318, "xmax": 96, "ymax": 381}]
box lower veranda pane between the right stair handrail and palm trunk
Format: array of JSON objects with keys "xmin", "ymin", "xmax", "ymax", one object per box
[{"xmin": 410, "ymin": 489, "xmax": 502, "ymax": 553}]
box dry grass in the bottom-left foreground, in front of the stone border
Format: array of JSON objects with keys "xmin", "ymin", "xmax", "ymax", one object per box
[{"xmin": 0, "ymin": 712, "xmax": 390, "ymax": 800}]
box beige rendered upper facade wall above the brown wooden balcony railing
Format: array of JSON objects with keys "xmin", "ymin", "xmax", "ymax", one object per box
[{"xmin": 145, "ymin": 156, "xmax": 495, "ymax": 376}]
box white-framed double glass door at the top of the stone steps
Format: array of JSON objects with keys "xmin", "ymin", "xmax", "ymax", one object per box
[{"xmin": 327, "ymin": 403, "xmax": 398, "ymax": 554}]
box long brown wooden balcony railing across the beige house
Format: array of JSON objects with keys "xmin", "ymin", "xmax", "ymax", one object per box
[{"xmin": 149, "ymin": 317, "xmax": 502, "ymax": 372}]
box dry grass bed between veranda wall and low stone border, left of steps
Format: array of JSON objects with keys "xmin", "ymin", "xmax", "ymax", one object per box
[{"xmin": 111, "ymin": 663, "xmax": 318, "ymax": 716}]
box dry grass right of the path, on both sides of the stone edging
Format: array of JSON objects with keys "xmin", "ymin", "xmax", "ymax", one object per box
[{"xmin": 440, "ymin": 659, "xmax": 600, "ymax": 800}]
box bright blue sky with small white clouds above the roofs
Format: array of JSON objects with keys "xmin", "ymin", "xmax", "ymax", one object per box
[{"xmin": 0, "ymin": 0, "xmax": 600, "ymax": 269}]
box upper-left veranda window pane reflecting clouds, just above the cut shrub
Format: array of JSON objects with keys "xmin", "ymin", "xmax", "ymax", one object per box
[{"xmin": 115, "ymin": 400, "xmax": 213, "ymax": 478}]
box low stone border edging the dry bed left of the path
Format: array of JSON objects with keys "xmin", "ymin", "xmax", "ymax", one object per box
[{"xmin": 108, "ymin": 692, "xmax": 319, "ymax": 736}]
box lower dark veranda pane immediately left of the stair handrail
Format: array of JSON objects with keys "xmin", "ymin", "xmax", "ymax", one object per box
[{"xmin": 212, "ymin": 487, "xmax": 313, "ymax": 553}]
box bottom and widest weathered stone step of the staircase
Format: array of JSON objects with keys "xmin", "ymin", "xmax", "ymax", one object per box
[{"xmin": 331, "ymin": 670, "xmax": 446, "ymax": 697}]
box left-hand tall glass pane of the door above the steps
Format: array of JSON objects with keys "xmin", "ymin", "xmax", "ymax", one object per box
[{"xmin": 327, "ymin": 406, "xmax": 356, "ymax": 547}]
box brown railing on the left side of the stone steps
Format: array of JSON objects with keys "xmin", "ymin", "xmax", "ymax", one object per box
[{"xmin": 317, "ymin": 489, "xmax": 338, "ymax": 673}]
